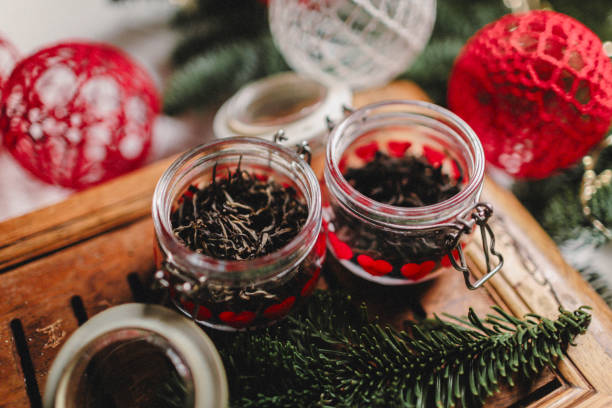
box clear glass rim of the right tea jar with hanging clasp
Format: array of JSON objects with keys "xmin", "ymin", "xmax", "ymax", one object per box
[{"xmin": 325, "ymin": 99, "xmax": 485, "ymax": 228}]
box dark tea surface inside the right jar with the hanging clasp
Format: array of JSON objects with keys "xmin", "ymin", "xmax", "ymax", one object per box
[{"xmin": 344, "ymin": 151, "xmax": 461, "ymax": 207}]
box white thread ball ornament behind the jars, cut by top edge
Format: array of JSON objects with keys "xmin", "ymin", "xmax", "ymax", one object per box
[{"xmin": 269, "ymin": 0, "xmax": 436, "ymax": 88}]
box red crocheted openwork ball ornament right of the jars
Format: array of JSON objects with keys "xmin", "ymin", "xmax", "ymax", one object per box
[{"xmin": 448, "ymin": 11, "xmax": 612, "ymax": 178}]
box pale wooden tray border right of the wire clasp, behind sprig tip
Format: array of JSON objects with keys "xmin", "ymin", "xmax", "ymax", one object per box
[{"xmin": 471, "ymin": 180, "xmax": 612, "ymax": 395}]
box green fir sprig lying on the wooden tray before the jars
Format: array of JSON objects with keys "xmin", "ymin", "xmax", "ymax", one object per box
[{"xmin": 216, "ymin": 291, "xmax": 591, "ymax": 407}]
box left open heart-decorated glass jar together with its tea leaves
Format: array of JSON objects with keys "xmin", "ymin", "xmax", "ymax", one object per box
[{"xmin": 153, "ymin": 137, "xmax": 326, "ymax": 330}]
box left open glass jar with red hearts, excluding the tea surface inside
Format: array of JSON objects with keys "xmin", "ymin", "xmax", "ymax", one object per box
[{"xmin": 153, "ymin": 137, "xmax": 325, "ymax": 330}]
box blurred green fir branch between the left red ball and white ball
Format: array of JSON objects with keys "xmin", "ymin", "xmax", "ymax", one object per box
[{"xmin": 159, "ymin": 0, "xmax": 289, "ymax": 115}]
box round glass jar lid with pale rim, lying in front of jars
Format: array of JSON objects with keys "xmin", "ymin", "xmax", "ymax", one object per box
[{"xmin": 44, "ymin": 303, "xmax": 229, "ymax": 408}]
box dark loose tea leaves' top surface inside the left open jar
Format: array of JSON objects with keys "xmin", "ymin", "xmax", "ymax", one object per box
[{"xmin": 171, "ymin": 162, "xmax": 308, "ymax": 261}]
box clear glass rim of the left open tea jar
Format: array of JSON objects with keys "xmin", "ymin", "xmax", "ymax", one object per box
[{"xmin": 152, "ymin": 136, "xmax": 321, "ymax": 279}]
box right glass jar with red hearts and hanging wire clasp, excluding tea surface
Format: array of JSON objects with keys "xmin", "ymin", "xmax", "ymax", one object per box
[{"xmin": 324, "ymin": 101, "xmax": 503, "ymax": 289}]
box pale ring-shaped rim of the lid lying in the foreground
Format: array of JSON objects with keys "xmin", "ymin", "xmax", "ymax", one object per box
[{"xmin": 43, "ymin": 303, "xmax": 229, "ymax": 408}]
